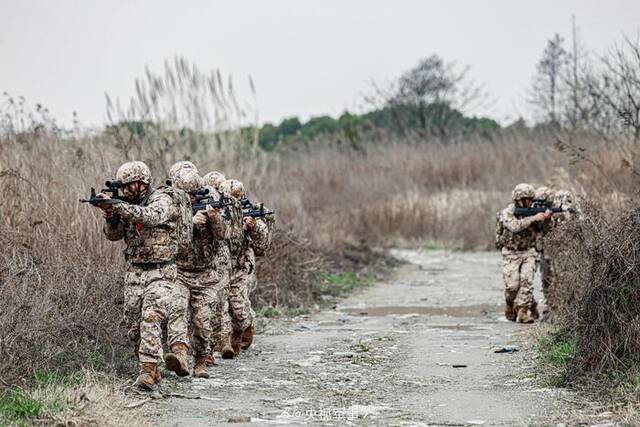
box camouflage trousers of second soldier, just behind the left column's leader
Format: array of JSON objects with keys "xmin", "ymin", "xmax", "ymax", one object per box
[{"xmin": 178, "ymin": 268, "xmax": 224, "ymax": 357}]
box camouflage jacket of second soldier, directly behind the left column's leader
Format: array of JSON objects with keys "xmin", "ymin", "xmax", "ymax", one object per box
[{"xmin": 178, "ymin": 187, "xmax": 232, "ymax": 271}]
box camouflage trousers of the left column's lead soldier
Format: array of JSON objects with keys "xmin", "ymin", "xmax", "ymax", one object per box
[{"xmin": 124, "ymin": 264, "xmax": 189, "ymax": 363}]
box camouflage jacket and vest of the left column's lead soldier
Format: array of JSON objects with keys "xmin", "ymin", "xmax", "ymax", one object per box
[{"xmin": 103, "ymin": 188, "xmax": 191, "ymax": 264}]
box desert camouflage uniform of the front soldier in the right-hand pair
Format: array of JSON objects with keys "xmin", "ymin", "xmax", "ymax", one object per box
[{"xmin": 496, "ymin": 204, "xmax": 538, "ymax": 309}]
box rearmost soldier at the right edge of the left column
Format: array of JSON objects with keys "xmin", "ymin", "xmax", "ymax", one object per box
[{"xmin": 222, "ymin": 179, "xmax": 271, "ymax": 355}]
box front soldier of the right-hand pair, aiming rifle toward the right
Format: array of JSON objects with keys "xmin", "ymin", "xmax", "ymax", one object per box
[{"xmin": 496, "ymin": 184, "xmax": 551, "ymax": 323}]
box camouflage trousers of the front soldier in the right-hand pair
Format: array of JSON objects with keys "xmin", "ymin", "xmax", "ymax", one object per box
[{"xmin": 502, "ymin": 248, "xmax": 537, "ymax": 309}]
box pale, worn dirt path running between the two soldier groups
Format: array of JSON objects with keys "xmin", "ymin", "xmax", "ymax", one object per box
[{"xmin": 145, "ymin": 251, "xmax": 596, "ymax": 426}]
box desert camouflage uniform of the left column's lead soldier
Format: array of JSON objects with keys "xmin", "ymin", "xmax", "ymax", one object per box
[{"xmin": 104, "ymin": 187, "xmax": 191, "ymax": 363}]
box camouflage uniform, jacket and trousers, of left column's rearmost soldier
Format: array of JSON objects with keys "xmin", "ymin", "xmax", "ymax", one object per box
[{"xmin": 229, "ymin": 218, "xmax": 271, "ymax": 331}]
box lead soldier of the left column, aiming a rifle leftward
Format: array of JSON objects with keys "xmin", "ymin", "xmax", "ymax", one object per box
[{"xmin": 97, "ymin": 162, "xmax": 191, "ymax": 389}]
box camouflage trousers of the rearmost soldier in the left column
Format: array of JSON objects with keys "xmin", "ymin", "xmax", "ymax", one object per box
[{"xmin": 229, "ymin": 268, "xmax": 258, "ymax": 331}]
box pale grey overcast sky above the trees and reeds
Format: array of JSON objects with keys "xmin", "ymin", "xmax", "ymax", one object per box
[{"xmin": 0, "ymin": 0, "xmax": 640, "ymax": 125}]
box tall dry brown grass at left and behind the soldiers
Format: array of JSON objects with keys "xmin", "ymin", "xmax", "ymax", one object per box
[{"xmin": 0, "ymin": 103, "xmax": 633, "ymax": 381}]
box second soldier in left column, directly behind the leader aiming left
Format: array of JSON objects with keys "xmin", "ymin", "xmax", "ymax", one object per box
[{"xmin": 171, "ymin": 168, "xmax": 227, "ymax": 378}]
